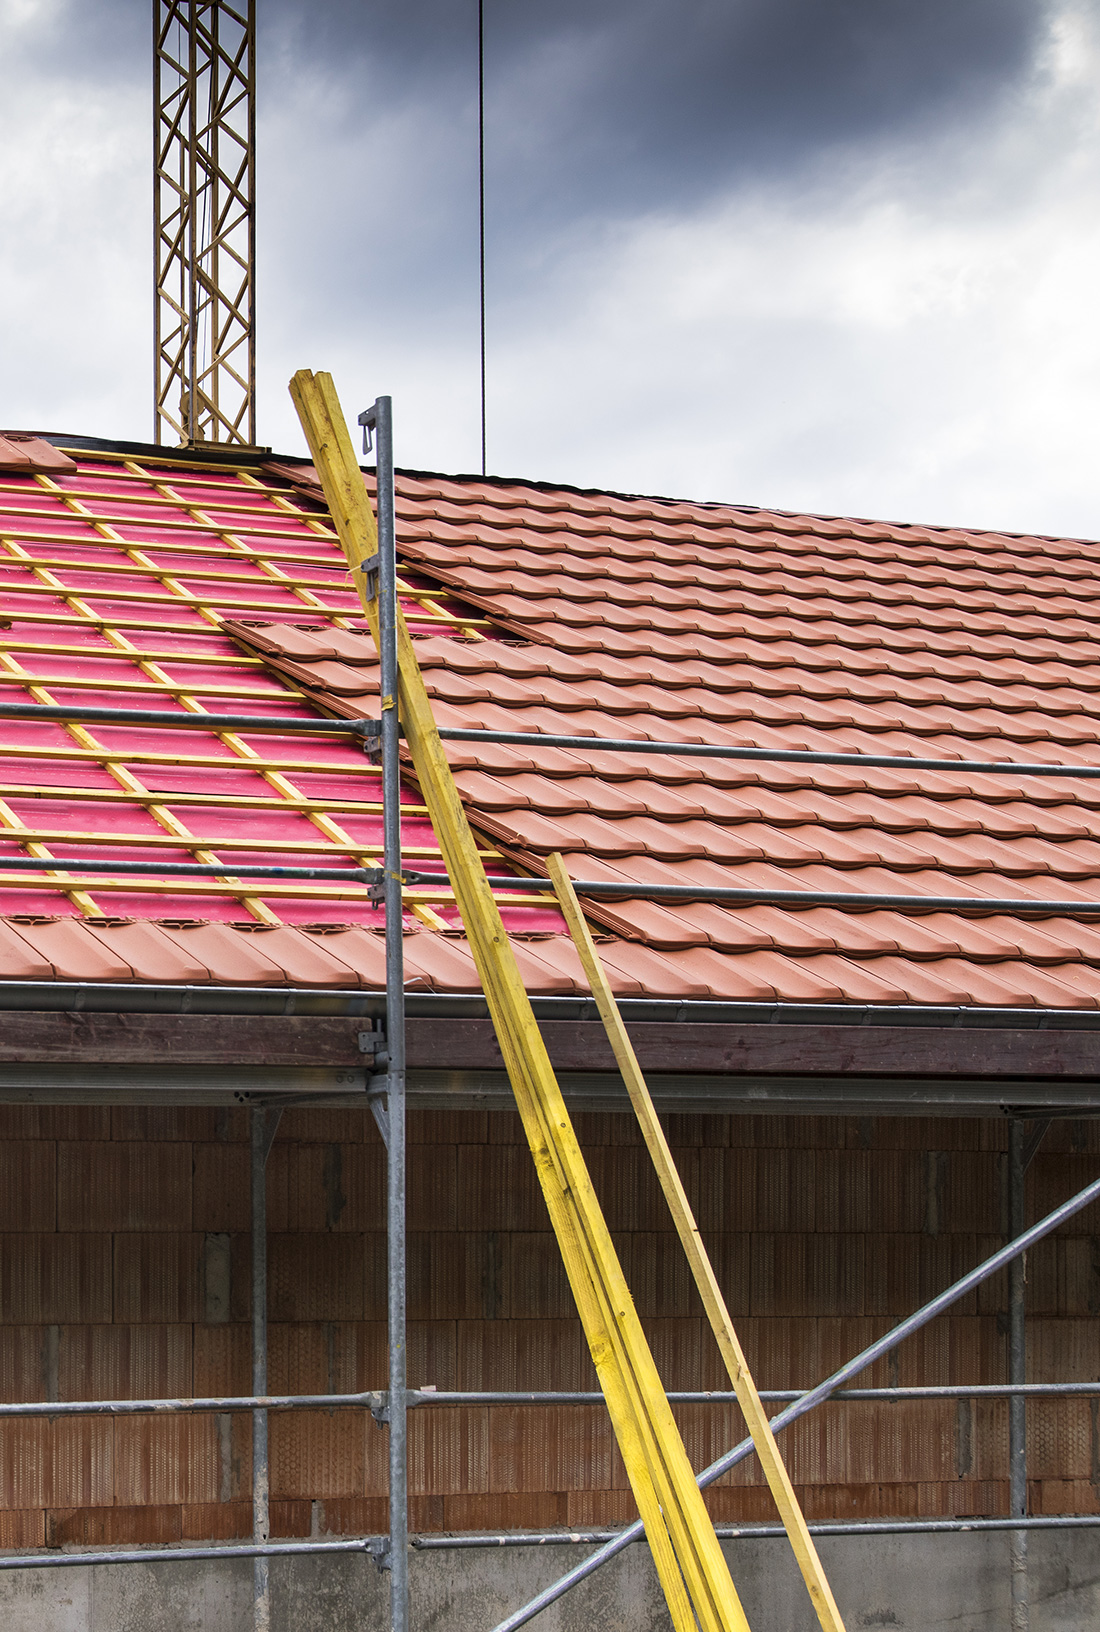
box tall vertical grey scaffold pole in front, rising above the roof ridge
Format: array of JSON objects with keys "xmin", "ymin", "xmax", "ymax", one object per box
[{"xmin": 374, "ymin": 397, "xmax": 408, "ymax": 1632}]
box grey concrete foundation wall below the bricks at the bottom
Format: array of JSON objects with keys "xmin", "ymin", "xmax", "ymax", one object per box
[{"xmin": 0, "ymin": 1531, "xmax": 1100, "ymax": 1632}]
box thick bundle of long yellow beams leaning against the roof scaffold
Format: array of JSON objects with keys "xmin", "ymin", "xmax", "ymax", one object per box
[{"xmin": 291, "ymin": 370, "xmax": 747, "ymax": 1632}]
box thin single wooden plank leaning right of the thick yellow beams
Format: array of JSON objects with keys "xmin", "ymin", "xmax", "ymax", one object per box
[{"xmin": 547, "ymin": 855, "xmax": 844, "ymax": 1632}]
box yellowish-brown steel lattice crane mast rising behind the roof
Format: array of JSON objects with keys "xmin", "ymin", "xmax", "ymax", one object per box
[{"xmin": 153, "ymin": 0, "xmax": 256, "ymax": 446}]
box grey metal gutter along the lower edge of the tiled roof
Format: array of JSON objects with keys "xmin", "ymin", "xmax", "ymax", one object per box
[{"xmin": 0, "ymin": 981, "xmax": 1100, "ymax": 1031}]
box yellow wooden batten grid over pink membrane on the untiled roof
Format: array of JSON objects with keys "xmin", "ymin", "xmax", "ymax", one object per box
[{"xmin": 0, "ymin": 454, "xmax": 509, "ymax": 927}]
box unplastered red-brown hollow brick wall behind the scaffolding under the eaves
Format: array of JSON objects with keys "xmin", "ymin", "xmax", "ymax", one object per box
[{"xmin": 0, "ymin": 1106, "xmax": 1100, "ymax": 1547}]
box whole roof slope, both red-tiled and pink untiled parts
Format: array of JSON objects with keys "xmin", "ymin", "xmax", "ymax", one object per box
[{"xmin": 0, "ymin": 449, "xmax": 1100, "ymax": 1009}]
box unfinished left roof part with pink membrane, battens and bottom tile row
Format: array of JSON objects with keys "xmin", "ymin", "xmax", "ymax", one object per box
[{"xmin": 0, "ymin": 439, "xmax": 558, "ymax": 991}]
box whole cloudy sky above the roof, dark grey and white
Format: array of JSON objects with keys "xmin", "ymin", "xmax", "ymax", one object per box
[{"xmin": 0, "ymin": 0, "xmax": 1100, "ymax": 537}]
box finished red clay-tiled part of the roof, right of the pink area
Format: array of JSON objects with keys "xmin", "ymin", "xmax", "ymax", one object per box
[{"xmin": 235, "ymin": 465, "xmax": 1100, "ymax": 1009}]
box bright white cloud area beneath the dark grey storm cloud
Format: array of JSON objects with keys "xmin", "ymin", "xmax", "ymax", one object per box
[{"xmin": 0, "ymin": 0, "xmax": 1100, "ymax": 535}]
